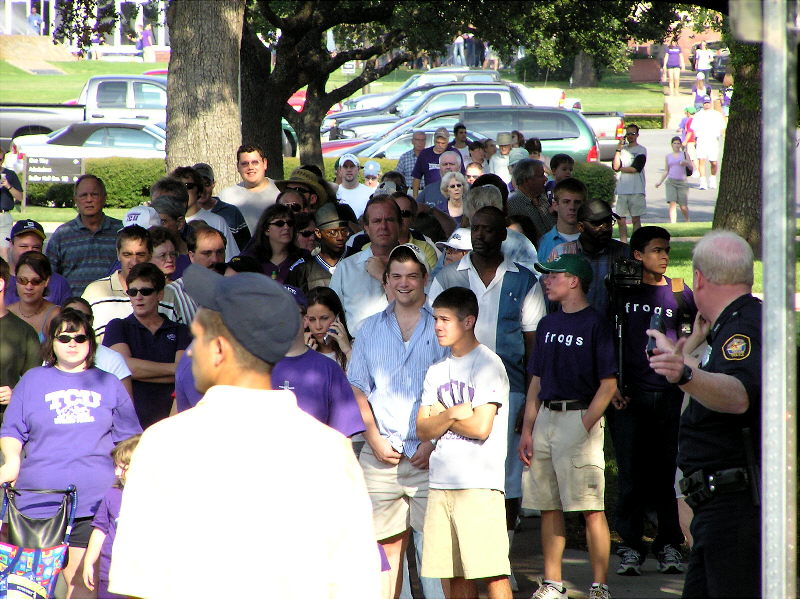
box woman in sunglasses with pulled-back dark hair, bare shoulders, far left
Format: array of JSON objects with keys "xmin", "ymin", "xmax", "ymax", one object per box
[{"xmin": 8, "ymin": 252, "xmax": 60, "ymax": 343}]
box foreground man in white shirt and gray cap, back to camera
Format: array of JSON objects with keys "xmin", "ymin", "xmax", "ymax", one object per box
[{"xmin": 110, "ymin": 265, "xmax": 381, "ymax": 599}]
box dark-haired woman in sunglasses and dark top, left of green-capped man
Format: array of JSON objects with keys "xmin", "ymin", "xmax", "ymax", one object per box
[{"xmin": 243, "ymin": 204, "xmax": 311, "ymax": 284}]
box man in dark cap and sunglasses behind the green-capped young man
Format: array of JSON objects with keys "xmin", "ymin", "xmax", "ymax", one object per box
[{"xmin": 547, "ymin": 200, "xmax": 631, "ymax": 316}]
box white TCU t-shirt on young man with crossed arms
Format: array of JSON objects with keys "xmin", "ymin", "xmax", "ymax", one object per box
[{"xmin": 422, "ymin": 345, "xmax": 509, "ymax": 491}]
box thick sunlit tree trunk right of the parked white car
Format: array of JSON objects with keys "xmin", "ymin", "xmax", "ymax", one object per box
[{"xmin": 167, "ymin": 0, "xmax": 245, "ymax": 189}]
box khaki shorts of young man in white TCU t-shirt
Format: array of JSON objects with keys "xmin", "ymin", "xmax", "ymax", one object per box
[{"xmin": 422, "ymin": 489, "xmax": 511, "ymax": 580}]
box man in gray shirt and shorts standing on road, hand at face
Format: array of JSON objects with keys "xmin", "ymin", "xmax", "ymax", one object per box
[{"xmin": 612, "ymin": 123, "xmax": 647, "ymax": 243}]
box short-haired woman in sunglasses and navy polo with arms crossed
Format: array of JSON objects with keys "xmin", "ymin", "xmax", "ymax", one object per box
[{"xmin": 103, "ymin": 262, "xmax": 191, "ymax": 428}]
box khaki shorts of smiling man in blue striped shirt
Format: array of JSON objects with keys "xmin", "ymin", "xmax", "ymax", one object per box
[{"xmin": 358, "ymin": 444, "xmax": 428, "ymax": 541}]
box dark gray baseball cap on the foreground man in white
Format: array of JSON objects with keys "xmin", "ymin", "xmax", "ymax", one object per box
[{"xmin": 183, "ymin": 264, "xmax": 300, "ymax": 364}]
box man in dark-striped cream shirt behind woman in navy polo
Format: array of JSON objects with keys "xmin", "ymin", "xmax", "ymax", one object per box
[{"xmin": 81, "ymin": 225, "xmax": 179, "ymax": 343}]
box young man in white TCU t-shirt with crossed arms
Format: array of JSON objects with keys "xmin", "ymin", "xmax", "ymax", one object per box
[{"xmin": 417, "ymin": 287, "xmax": 511, "ymax": 599}]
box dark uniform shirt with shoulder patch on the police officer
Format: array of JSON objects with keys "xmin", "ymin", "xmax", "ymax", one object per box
[{"xmin": 678, "ymin": 294, "xmax": 761, "ymax": 476}]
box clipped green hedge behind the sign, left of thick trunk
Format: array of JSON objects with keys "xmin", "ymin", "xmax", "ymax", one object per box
[{"xmin": 28, "ymin": 158, "xmax": 166, "ymax": 208}]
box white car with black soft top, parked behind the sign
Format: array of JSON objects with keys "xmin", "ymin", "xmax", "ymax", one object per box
[{"xmin": 3, "ymin": 122, "xmax": 167, "ymax": 174}]
